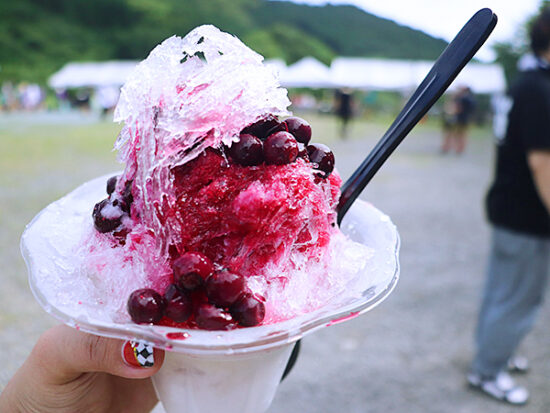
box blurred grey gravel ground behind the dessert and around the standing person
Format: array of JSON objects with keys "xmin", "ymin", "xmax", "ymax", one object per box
[{"xmin": 0, "ymin": 114, "xmax": 550, "ymax": 413}]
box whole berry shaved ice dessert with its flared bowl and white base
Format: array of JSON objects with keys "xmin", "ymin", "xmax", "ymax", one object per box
[{"xmin": 21, "ymin": 26, "xmax": 399, "ymax": 413}]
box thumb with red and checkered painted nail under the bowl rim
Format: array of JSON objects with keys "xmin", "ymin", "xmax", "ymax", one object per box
[{"xmin": 31, "ymin": 325, "xmax": 164, "ymax": 384}]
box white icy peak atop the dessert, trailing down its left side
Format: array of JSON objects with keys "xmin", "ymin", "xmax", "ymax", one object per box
[{"xmin": 111, "ymin": 25, "xmax": 290, "ymax": 262}]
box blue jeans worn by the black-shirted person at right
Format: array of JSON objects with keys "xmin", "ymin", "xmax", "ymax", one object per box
[{"xmin": 472, "ymin": 228, "xmax": 550, "ymax": 377}]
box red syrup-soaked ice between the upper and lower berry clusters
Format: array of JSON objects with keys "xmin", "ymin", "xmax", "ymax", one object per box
[{"xmin": 166, "ymin": 149, "xmax": 341, "ymax": 277}]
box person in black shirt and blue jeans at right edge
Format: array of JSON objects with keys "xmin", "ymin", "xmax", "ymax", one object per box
[{"xmin": 467, "ymin": 9, "xmax": 550, "ymax": 404}]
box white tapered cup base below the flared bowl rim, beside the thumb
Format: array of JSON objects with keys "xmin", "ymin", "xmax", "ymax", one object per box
[{"xmin": 153, "ymin": 343, "xmax": 294, "ymax": 413}]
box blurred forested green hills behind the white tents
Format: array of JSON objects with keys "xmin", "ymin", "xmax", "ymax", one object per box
[{"xmin": 0, "ymin": 0, "xmax": 446, "ymax": 83}]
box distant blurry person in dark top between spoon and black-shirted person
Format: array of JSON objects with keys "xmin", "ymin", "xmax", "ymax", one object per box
[{"xmin": 441, "ymin": 86, "xmax": 476, "ymax": 154}]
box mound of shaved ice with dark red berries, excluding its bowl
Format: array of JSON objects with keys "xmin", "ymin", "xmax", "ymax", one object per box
[{"xmin": 66, "ymin": 26, "xmax": 372, "ymax": 330}]
